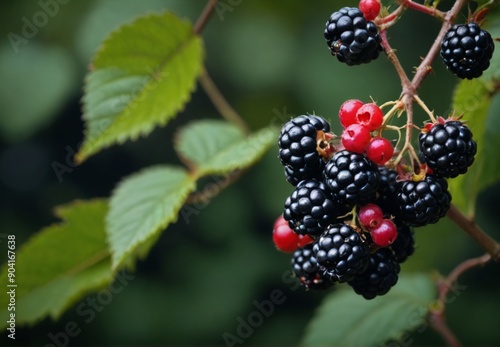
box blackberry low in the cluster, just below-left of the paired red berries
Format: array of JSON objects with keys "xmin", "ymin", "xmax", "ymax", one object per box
[{"xmin": 313, "ymin": 224, "xmax": 370, "ymax": 282}]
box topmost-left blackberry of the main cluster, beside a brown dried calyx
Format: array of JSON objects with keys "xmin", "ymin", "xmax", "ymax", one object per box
[{"xmin": 278, "ymin": 115, "xmax": 330, "ymax": 186}]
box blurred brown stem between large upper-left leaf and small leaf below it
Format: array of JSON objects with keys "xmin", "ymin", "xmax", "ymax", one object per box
[{"xmin": 199, "ymin": 69, "xmax": 249, "ymax": 135}]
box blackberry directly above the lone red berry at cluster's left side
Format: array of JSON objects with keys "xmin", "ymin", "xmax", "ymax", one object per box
[{"xmin": 283, "ymin": 180, "xmax": 338, "ymax": 236}]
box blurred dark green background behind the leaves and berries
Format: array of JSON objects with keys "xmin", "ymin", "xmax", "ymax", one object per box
[{"xmin": 0, "ymin": 0, "xmax": 500, "ymax": 346}]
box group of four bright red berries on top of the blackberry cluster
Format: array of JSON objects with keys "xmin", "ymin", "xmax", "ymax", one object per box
[{"xmin": 339, "ymin": 99, "xmax": 394, "ymax": 165}]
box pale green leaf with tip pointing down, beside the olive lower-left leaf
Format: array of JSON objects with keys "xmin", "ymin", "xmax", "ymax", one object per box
[{"xmin": 106, "ymin": 166, "xmax": 196, "ymax": 269}]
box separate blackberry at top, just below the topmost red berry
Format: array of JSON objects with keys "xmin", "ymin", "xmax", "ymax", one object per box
[{"xmin": 324, "ymin": 7, "xmax": 382, "ymax": 66}]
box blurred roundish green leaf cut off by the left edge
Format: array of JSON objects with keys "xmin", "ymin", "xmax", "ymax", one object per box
[{"xmin": 0, "ymin": 44, "xmax": 79, "ymax": 141}]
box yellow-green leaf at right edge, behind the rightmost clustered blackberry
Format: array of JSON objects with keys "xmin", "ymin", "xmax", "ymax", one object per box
[{"xmin": 449, "ymin": 79, "xmax": 500, "ymax": 217}]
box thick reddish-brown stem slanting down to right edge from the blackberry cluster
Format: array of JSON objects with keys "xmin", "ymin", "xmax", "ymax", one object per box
[{"xmin": 447, "ymin": 204, "xmax": 500, "ymax": 262}]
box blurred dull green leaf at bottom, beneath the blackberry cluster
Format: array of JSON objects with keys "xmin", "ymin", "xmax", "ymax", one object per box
[{"xmin": 303, "ymin": 274, "xmax": 436, "ymax": 347}]
